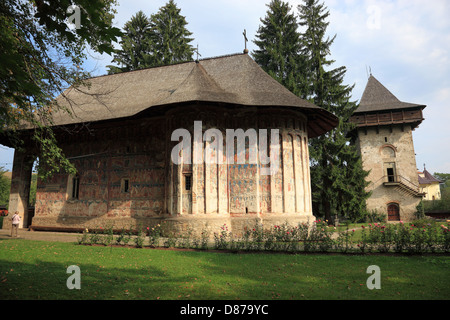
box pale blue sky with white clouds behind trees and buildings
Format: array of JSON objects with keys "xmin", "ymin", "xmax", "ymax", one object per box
[{"xmin": 0, "ymin": 0, "xmax": 450, "ymax": 173}]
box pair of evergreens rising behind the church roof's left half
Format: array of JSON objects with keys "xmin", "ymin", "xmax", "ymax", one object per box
[{"xmin": 108, "ymin": 0, "xmax": 194, "ymax": 74}]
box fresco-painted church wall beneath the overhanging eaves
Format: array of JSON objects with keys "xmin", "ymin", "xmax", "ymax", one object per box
[{"xmin": 28, "ymin": 105, "xmax": 312, "ymax": 235}]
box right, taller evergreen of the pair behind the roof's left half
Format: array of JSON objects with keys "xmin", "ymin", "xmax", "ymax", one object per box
[{"xmin": 150, "ymin": 0, "xmax": 194, "ymax": 65}]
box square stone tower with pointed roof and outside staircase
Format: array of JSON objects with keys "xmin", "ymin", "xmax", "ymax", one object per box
[{"xmin": 351, "ymin": 75, "xmax": 425, "ymax": 221}]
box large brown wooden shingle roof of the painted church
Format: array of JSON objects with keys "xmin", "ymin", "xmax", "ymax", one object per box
[{"xmin": 53, "ymin": 54, "xmax": 338, "ymax": 137}]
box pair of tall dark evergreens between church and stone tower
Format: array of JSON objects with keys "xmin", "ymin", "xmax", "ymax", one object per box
[{"xmin": 253, "ymin": 0, "xmax": 368, "ymax": 220}]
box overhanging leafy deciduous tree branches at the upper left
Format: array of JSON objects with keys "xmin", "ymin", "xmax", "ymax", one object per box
[{"xmin": 0, "ymin": 0, "xmax": 121, "ymax": 180}]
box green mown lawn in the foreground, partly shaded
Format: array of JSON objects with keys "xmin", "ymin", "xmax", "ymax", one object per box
[{"xmin": 0, "ymin": 239, "xmax": 450, "ymax": 300}]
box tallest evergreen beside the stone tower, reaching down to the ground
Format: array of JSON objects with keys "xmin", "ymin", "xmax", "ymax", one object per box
[{"xmin": 298, "ymin": 0, "xmax": 368, "ymax": 221}]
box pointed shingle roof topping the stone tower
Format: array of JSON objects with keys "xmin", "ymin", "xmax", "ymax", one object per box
[{"xmin": 355, "ymin": 75, "xmax": 425, "ymax": 113}]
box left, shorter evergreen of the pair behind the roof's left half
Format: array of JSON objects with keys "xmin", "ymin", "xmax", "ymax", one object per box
[{"xmin": 108, "ymin": 11, "xmax": 155, "ymax": 74}]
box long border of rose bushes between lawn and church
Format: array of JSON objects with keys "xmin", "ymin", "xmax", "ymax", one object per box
[{"xmin": 78, "ymin": 219, "xmax": 450, "ymax": 254}]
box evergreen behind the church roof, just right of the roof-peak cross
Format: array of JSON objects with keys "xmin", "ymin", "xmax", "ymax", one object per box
[{"xmin": 252, "ymin": 0, "xmax": 302, "ymax": 95}]
